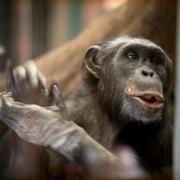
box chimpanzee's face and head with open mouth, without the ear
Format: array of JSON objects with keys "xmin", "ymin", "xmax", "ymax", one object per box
[{"xmin": 83, "ymin": 38, "xmax": 170, "ymax": 122}]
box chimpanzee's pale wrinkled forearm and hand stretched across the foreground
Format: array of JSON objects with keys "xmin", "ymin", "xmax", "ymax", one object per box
[{"xmin": 0, "ymin": 93, "xmax": 146, "ymax": 178}]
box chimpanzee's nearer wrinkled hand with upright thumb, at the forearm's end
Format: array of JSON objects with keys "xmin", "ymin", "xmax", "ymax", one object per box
[{"xmin": 0, "ymin": 88, "xmax": 76, "ymax": 146}]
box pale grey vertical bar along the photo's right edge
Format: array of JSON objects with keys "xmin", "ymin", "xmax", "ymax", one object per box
[{"xmin": 173, "ymin": 0, "xmax": 180, "ymax": 180}]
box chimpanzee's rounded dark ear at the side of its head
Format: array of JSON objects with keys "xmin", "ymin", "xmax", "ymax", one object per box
[{"xmin": 85, "ymin": 45, "xmax": 102, "ymax": 78}]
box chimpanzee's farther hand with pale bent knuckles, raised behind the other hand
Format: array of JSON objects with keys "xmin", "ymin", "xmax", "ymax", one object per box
[{"xmin": 6, "ymin": 61, "xmax": 49, "ymax": 106}]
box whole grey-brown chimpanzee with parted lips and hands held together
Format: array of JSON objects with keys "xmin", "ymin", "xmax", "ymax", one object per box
[{"xmin": 0, "ymin": 36, "xmax": 172, "ymax": 179}]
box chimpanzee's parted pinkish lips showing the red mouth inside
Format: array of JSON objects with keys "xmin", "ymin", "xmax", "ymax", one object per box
[{"xmin": 128, "ymin": 92, "xmax": 164, "ymax": 109}]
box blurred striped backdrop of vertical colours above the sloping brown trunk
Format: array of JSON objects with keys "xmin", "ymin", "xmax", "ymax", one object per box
[{"xmin": 0, "ymin": 0, "xmax": 125, "ymax": 71}]
